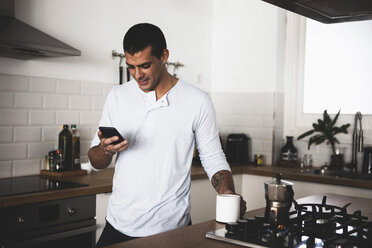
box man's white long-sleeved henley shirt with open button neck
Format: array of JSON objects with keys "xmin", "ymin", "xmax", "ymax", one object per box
[{"xmin": 91, "ymin": 80, "xmax": 230, "ymax": 237}]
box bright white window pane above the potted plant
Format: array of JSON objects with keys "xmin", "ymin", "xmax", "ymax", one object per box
[{"xmin": 303, "ymin": 19, "xmax": 372, "ymax": 114}]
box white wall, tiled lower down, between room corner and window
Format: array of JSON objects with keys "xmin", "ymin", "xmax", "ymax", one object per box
[{"xmin": 211, "ymin": 0, "xmax": 285, "ymax": 164}]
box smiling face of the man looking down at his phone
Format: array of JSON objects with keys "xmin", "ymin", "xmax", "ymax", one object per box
[{"xmin": 125, "ymin": 46, "xmax": 168, "ymax": 92}]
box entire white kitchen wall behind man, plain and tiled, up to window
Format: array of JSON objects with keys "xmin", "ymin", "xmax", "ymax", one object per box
[{"xmin": 0, "ymin": 0, "xmax": 284, "ymax": 177}]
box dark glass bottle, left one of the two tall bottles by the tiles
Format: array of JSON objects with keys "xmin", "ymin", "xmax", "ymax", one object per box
[{"xmin": 58, "ymin": 125, "xmax": 72, "ymax": 171}]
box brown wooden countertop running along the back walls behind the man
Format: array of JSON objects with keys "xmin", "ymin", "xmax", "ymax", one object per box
[{"xmin": 0, "ymin": 165, "xmax": 372, "ymax": 207}]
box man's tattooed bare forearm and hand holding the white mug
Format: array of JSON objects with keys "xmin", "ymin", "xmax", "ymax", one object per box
[{"xmin": 211, "ymin": 170, "xmax": 247, "ymax": 217}]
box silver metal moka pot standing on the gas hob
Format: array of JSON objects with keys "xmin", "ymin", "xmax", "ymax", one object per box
[{"xmin": 265, "ymin": 174, "xmax": 294, "ymax": 225}]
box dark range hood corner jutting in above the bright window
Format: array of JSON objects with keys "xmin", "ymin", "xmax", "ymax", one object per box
[{"xmin": 263, "ymin": 0, "xmax": 372, "ymax": 24}]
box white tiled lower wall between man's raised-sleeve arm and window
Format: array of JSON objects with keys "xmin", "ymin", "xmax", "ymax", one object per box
[{"xmin": 211, "ymin": 92, "xmax": 274, "ymax": 164}]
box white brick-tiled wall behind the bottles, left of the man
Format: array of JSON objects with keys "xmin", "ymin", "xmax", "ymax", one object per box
[{"xmin": 0, "ymin": 74, "xmax": 113, "ymax": 178}]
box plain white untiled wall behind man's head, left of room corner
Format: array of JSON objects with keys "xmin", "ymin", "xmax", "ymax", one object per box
[{"xmin": 0, "ymin": 0, "xmax": 212, "ymax": 89}]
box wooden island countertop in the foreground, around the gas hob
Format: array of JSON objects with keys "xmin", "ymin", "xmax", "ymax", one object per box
[{"xmin": 107, "ymin": 194, "xmax": 372, "ymax": 248}]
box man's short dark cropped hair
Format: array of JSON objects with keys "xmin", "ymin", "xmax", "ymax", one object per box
[{"xmin": 123, "ymin": 23, "xmax": 167, "ymax": 59}]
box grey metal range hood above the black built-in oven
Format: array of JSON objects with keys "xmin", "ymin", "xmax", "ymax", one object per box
[{"xmin": 0, "ymin": 0, "xmax": 81, "ymax": 59}]
